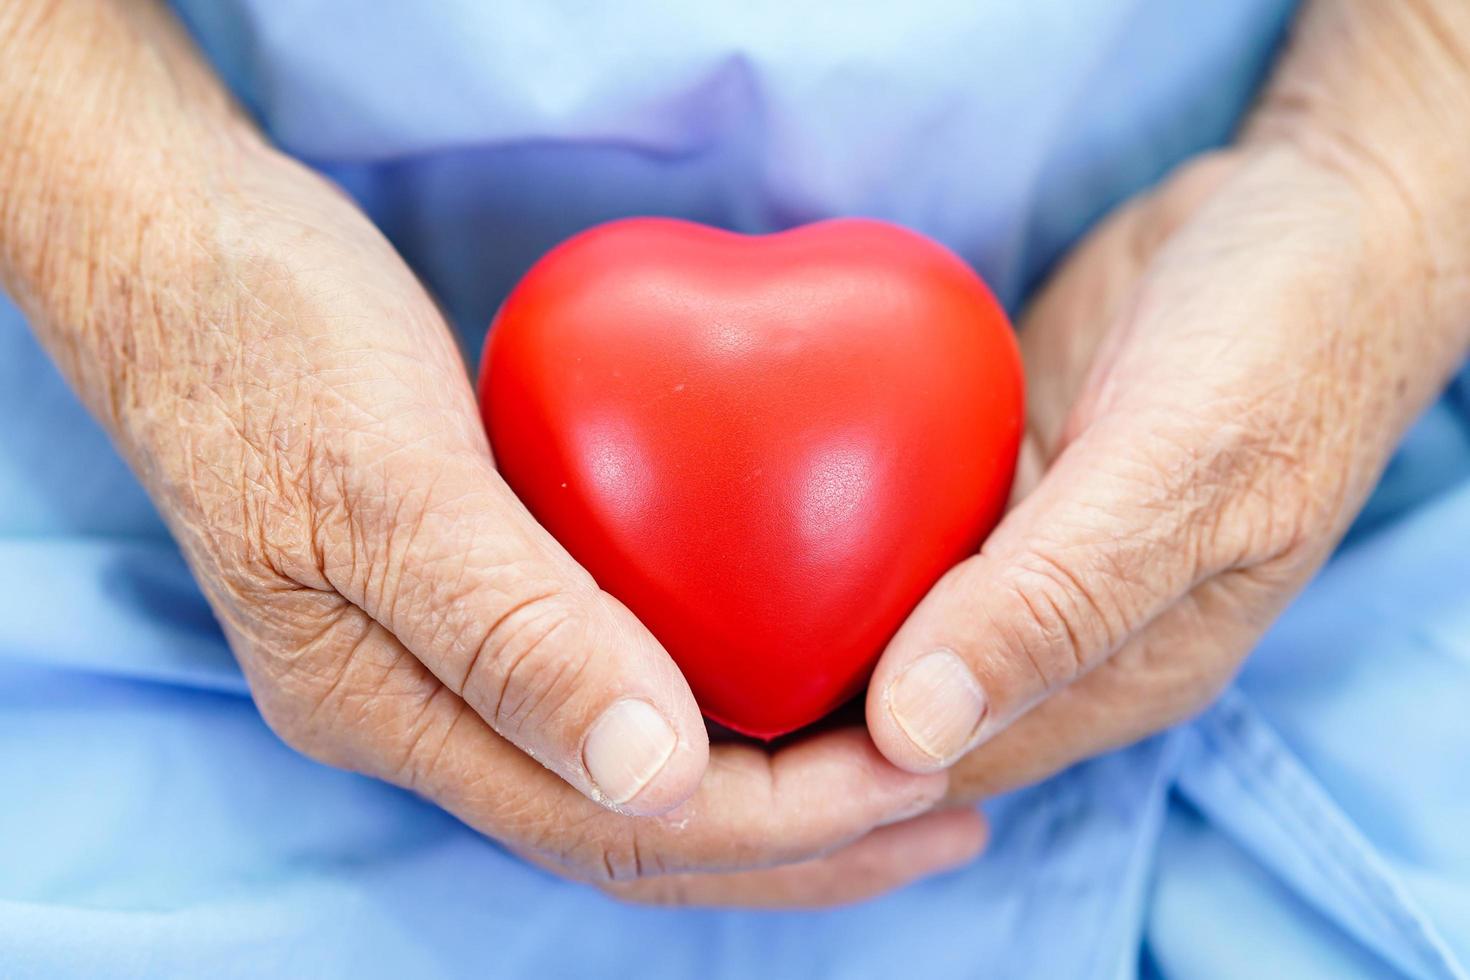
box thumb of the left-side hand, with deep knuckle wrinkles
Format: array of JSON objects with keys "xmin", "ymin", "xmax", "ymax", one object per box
[{"xmin": 314, "ymin": 445, "xmax": 709, "ymax": 814}]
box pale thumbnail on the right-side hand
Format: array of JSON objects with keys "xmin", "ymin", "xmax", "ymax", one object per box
[{"xmin": 886, "ymin": 649, "xmax": 985, "ymax": 764}]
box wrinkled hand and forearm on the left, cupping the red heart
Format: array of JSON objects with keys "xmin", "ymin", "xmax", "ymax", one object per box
[{"xmin": 0, "ymin": 0, "xmax": 982, "ymax": 904}]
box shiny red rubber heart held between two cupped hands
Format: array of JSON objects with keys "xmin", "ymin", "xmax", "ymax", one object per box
[{"xmin": 479, "ymin": 219, "xmax": 1022, "ymax": 738}]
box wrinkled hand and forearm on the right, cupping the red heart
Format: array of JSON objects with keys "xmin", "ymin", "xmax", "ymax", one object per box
[{"xmin": 867, "ymin": 0, "xmax": 1470, "ymax": 798}]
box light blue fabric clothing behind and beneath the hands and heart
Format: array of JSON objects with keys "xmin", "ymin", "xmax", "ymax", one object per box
[{"xmin": 0, "ymin": 0, "xmax": 1470, "ymax": 980}]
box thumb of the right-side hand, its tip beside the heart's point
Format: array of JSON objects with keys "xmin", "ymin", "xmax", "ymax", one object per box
[{"xmin": 867, "ymin": 411, "xmax": 1216, "ymax": 771}]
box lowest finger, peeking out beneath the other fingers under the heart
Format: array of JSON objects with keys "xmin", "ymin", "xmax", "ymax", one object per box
[{"xmin": 606, "ymin": 808, "xmax": 985, "ymax": 908}]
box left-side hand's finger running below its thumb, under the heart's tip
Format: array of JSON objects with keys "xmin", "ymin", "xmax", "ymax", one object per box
[{"xmin": 258, "ymin": 613, "xmax": 948, "ymax": 882}]
